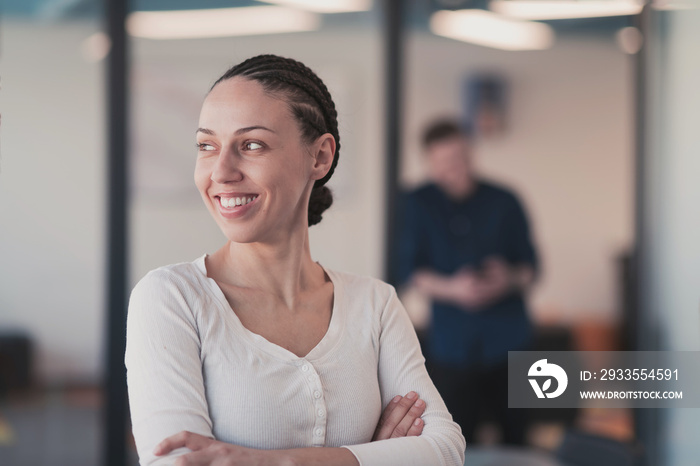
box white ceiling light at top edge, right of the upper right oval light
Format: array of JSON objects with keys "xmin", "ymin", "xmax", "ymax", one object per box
[{"xmin": 489, "ymin": 0, "xmax": 643, "ymax": 21}]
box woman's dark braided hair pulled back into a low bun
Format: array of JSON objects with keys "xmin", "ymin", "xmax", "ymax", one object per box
[{"xmin": 211, "ymin": 55, "xmax": 340, "ymax": 226}]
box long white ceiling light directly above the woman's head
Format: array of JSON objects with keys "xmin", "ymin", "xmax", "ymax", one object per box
[{"xmin": 126, "ymin": 6, "xmax": 321, "ymax": 39}]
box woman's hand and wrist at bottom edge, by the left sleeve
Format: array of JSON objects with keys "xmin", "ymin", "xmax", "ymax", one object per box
[{"xmin": 153, "ymin": 431, "xmax": 286, "ymax": 466}]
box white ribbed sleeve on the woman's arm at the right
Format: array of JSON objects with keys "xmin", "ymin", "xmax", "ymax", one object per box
[{"xmin": 346, "ymin": 288, "xmax": 466, "ymax": 466}]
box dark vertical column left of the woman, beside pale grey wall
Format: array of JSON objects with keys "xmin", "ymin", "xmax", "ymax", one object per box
[{"xmin": 103, "ymin": 0, "xmax": 129, "ymax": 466}]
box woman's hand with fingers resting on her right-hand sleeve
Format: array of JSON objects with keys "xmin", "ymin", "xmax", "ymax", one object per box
[{"xmin": 372, "ymin": 392, "xmax": 425, "ymax": 442}]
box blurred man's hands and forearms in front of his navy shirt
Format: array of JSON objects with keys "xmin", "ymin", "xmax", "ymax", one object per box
[{"xmin": 412, "ymin": 257, "xmax": 534, "ymax": 310}]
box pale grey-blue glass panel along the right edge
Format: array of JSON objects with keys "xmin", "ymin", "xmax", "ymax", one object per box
[{"xmin": 640, "ymin": 2, "xmax": 700, "ymax": 466}]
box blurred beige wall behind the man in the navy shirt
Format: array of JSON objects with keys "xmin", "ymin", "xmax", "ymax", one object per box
[{"xmin": 402, "ymin": 31, "xmax": 634, "ymax": 324}]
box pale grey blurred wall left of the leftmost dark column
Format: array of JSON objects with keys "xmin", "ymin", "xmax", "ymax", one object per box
[{"xmin": 0, "ymin": 16, "xmax": 106, "ymax": 384}]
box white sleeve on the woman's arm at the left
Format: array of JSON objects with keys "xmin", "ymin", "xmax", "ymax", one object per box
[{"xmin": 125, "ymin": 270, "xmax": 213, "ymax": 465}]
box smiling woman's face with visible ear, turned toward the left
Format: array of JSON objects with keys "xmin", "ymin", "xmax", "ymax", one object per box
[{"xmin": 195, "ymin": 77, "xmax": 335, "ymax": 243}]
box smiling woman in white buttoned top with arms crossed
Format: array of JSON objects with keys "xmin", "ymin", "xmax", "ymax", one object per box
[{"xmin": 126, "ymin": 55, "xmax": 465, "ymax": 466}]
